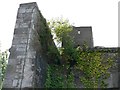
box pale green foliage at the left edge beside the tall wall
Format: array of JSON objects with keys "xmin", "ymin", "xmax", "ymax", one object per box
[{"xmin": 0, "ymin": 51, "xmax": 8, "ymax": 89}]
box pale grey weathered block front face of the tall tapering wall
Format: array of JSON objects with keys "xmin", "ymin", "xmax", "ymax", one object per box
[{"xmin": 3, "ymin": 3, "xmax": 47, "ymax": 89}]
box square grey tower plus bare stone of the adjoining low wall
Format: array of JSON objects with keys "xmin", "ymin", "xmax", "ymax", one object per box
[{"xmin": 70, "ymin": 27, "xmax": 120, "ymax": 88}]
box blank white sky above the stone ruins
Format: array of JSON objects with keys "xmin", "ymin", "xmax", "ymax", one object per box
[{"xmin": 0, "ymin": 0, "xmax": 120, "ymax": 50}]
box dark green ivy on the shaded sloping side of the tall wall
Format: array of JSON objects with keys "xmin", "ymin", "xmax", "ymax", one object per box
[{"xmin": 37, "ymin": 14, "xmax": 59, "ymax": 63}]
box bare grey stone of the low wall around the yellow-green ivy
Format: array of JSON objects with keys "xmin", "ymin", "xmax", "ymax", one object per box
[{"xmin": 73, "ymin": 47, "xmax": 120, "ymax": 88}]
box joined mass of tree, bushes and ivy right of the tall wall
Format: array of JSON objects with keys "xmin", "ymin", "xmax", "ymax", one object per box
[{"xmin": 45, "ymin": 19, "xmax": 115, "ymax": 88}]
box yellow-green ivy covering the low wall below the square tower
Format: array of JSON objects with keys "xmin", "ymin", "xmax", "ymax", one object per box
[{"xmin": 76, "ymin": 47, "xmax": 114, "ymax": 88}]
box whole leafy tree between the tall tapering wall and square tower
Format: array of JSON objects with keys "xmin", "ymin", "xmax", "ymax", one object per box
[{"xmin": 48, "ymin": 18, "xmax": 74, "ymax": 64}]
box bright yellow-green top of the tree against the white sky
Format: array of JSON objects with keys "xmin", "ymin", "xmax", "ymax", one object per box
[{"xmin": 48, "ymin": 18, "xmax": 72, "ymax": 43}]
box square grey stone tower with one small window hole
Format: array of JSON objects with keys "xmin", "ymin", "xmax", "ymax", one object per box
[{"xmin": 70, "ymin": 26, "xmax": 93, "ymax": 48}]
